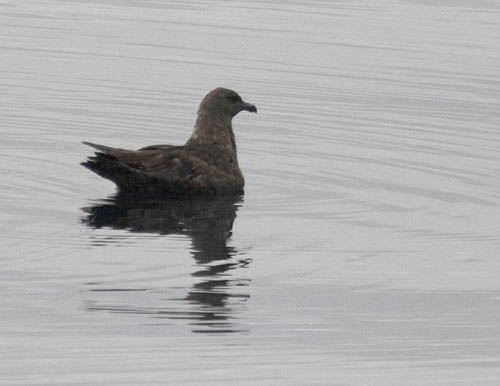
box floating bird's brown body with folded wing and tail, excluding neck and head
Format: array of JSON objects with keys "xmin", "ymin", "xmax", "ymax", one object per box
[{"xmin": 82, "ymin": 142, "xmax": 244, "ymax": 195}]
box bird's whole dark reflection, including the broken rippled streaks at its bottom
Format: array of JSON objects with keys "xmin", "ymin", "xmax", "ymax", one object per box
[{"xmin": 82, "ymin": 192, "xmax": 250, "ymax": 333}]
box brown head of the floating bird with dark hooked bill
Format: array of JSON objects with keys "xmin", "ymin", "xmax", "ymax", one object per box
[{"xmin": 198, "ymin": 87, "xmax": 257, "ymax": 118}]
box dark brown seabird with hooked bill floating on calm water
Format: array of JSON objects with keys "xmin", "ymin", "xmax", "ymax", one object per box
[{"xmin": 81, "ymin": 87, "xmax": 257, "ymax": 197}]
